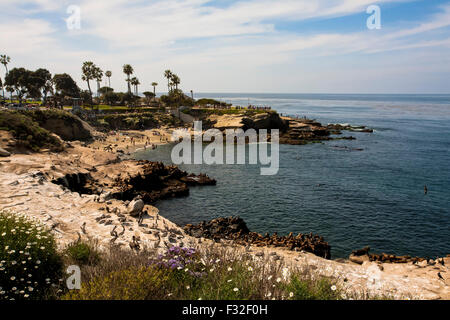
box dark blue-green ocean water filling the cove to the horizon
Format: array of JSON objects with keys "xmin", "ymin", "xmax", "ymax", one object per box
[{"xmin": 136, "ymin": 94, "xmax": 450, "ymax": 258}]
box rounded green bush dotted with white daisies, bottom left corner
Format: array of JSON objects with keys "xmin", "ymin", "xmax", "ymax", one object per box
[{"xmin": 0, "ymin": 212, "xmax": 63, "ymax": 300}]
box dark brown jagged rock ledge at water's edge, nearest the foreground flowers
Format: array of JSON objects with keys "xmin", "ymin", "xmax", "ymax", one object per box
[{"xmin": 184, "ymin": 217, "xmax": 331, "ymax": 259}]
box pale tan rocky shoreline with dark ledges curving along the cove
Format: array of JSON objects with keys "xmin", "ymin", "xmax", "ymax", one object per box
[{"xmin": 0, "ymin": 111, "xmax": 450, "ymax": 299}]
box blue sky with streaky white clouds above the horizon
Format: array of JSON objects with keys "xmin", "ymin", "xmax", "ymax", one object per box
[{"xmin": 0, "ymin": 0, "xmax": 450, "ymax": 94}]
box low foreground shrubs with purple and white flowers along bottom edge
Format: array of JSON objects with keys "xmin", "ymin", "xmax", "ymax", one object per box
[{"xmin": 62, "ymin": 247, "xmax": 352, "ymax": 300}]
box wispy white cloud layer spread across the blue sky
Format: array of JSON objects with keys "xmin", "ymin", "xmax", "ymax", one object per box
[{"xmin": 0, "ymin": 0, "xmax": 450, "ymax": 91}]
